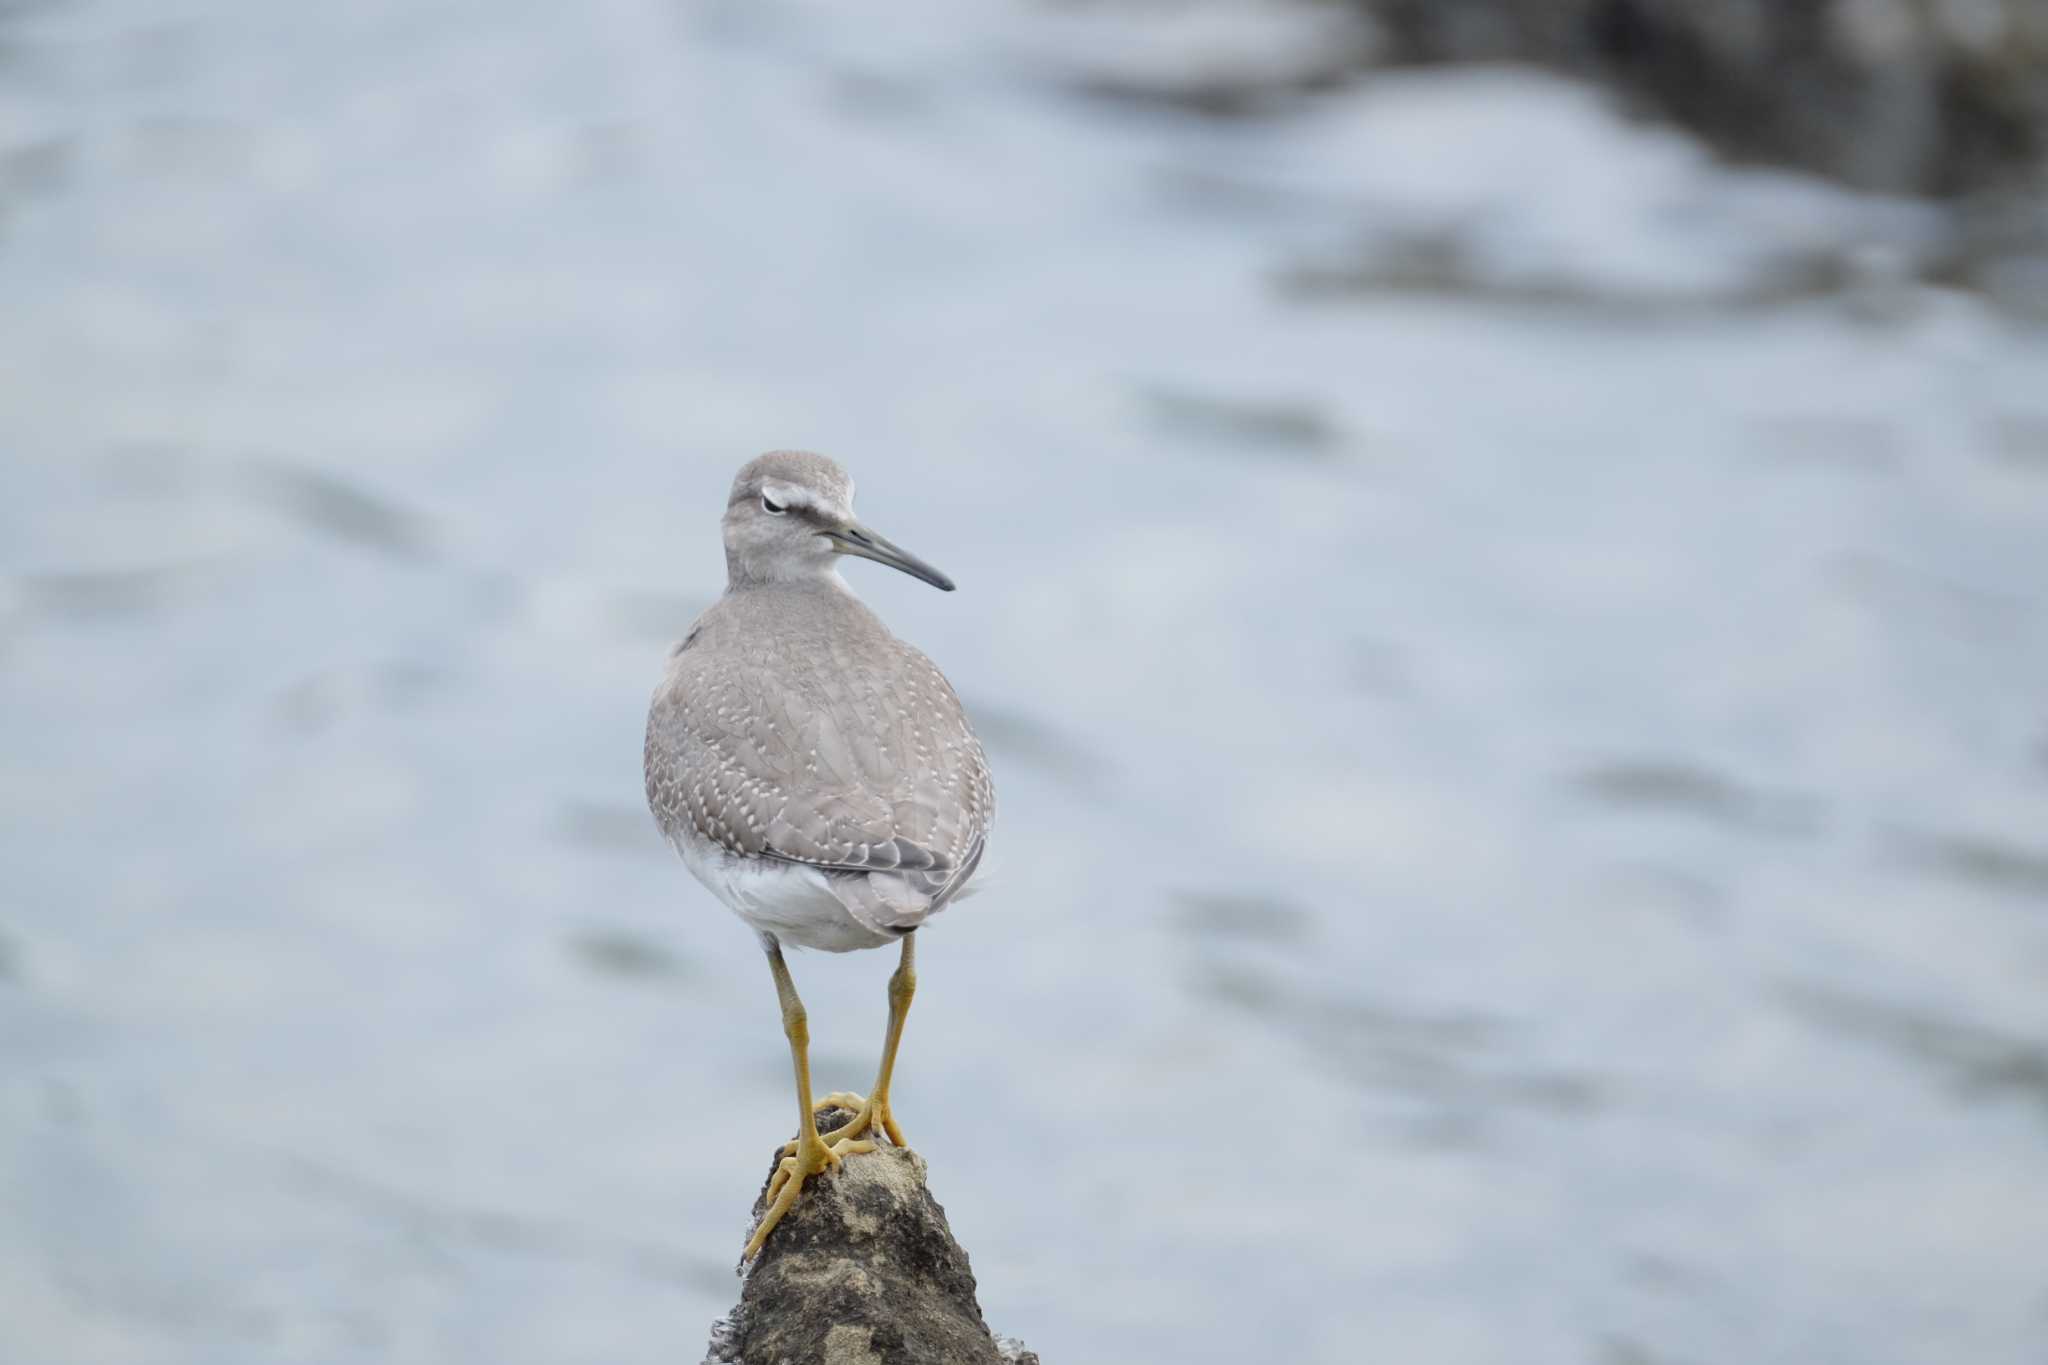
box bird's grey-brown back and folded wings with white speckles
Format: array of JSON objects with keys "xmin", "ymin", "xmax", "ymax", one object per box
[{"xmin": 645, "ymin": 585, "xmax": 995, "ymax": 909}]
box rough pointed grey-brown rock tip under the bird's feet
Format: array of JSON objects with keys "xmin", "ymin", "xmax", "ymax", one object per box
[{"xmin": 705, "ymin": 1109, "xmax": 1038, "ymax": 1365}]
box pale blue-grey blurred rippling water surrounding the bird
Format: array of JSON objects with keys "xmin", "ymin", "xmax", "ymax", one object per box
[{"xmin": 0, "ymin": 0, "xmax": 2048, "ymax": 1365}]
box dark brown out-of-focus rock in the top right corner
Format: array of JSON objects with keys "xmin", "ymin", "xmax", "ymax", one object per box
[{"xmin": 1352, "ymin": 0, "xmax": 2048, "ymax": 194}]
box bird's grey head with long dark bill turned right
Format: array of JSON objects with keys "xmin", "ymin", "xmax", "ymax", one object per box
[{"xmin": 725, "ymin": 450, "xmax": 952, "ymax": 591}]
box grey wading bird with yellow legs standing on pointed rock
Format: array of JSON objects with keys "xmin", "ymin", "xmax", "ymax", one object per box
[{"xmin": 643, "ymin": 450, "xmax": 995, "ymax": 1263}]
